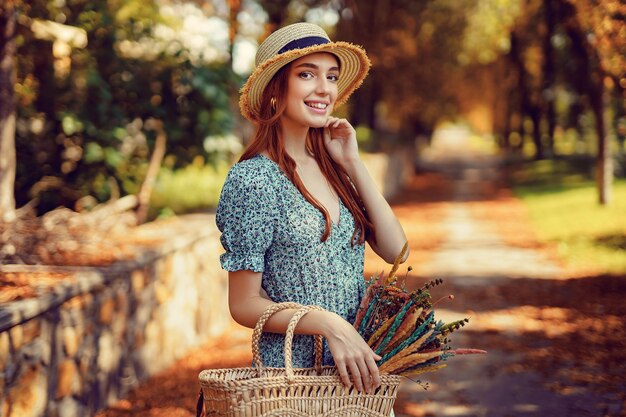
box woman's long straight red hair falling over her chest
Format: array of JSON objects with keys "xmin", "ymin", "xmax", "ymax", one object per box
[{"xmin": 239, "ymin": 65, "xmax": 374, "ymax": 244}]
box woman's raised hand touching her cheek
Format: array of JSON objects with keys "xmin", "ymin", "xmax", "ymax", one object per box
[{"xmin": 324, "ymin": 117, "xmax": 359, "ymax": 170}]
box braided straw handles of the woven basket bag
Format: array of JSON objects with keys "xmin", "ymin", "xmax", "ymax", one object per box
[{"xmin": 252, "ymin": 302, "xmax": 324, "ymax": 380}]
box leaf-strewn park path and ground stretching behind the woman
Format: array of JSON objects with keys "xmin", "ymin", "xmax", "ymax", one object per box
[{"xmin": 98, "ymin": 129, "xmax": 626, "ymax": 417}]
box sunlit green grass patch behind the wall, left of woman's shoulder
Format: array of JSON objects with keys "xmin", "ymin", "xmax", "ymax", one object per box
[{"xmin": 150, "ymin": 162, "xmax": 231, "ymax": 218}]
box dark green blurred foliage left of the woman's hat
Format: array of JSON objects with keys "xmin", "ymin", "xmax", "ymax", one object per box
[{"xmin": 15, "ymin": 0, "xmax": 241, "ymax": 212}]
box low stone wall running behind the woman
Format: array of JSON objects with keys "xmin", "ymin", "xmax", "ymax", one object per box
[{"xmin": 0, "ymin": 146, "xmax": 412, "ymax": 417}]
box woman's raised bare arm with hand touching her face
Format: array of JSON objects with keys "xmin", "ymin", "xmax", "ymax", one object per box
[{"xmin": 324, "ymin": 117, "xmax": 409, "ymax": 264}]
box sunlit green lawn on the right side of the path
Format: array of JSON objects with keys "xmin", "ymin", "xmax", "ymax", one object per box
[{"xmin": 512, "ymin": 160, "xmax": 626, "ymax": 274}]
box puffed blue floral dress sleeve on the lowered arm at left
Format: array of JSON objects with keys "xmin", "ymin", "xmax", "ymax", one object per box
[{"xmin": 216, "ymin": 166, "xmax": 277, "ymax": 272}]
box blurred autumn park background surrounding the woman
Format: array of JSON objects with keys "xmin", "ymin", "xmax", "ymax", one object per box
[{"xmin": 0, "ymin": 0, "xmax": 626, "ymax": 417}]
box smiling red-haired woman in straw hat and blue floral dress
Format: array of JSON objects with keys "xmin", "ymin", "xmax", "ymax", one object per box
[{"xmin": 216, "ymin": 23, "xmax": 408, "ymax": 393}]
